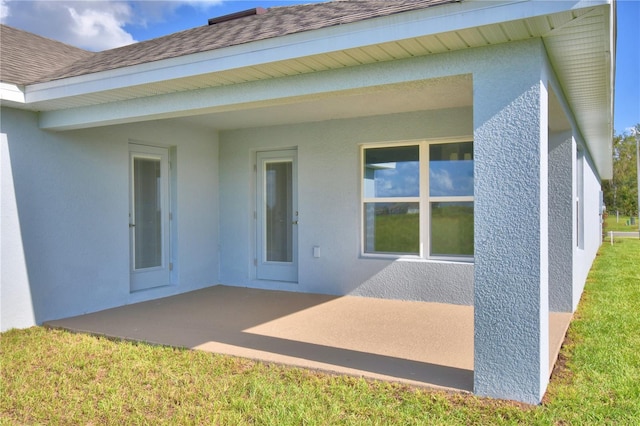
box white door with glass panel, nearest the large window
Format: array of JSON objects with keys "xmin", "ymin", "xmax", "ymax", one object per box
[{"xmin": 255, "ymin": 150, "xmax": 298, "ymax": 282}]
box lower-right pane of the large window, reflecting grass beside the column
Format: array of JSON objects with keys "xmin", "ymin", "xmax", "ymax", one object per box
[{"xmin": 431, "ymin": 202, "xmax": 473, "ymax": 256}]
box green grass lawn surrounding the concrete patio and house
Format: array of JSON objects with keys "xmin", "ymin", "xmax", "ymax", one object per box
[{"xmin": 0, "ymin": 240, "xmax": 640, "ymax": 425}]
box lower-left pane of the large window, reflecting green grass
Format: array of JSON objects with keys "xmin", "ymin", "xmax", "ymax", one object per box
[{"xmin": 364, "ymin": 203, "xmax": 420, "ymax": 254}]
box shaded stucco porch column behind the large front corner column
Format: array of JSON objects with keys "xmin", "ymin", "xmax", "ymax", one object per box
[{"xmin": 549, "ymin": 131, "xmax": 577, "ymax": 312}]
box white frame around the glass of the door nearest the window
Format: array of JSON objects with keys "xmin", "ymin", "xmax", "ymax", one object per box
[{"xmin": 253, "ymin": 148, "xmax": 299, "ymax": 283}]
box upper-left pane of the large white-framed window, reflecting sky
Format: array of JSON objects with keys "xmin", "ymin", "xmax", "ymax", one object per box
[{"xmin": 364, "ymin": 145, "xmax": 420, "ymax": 198}]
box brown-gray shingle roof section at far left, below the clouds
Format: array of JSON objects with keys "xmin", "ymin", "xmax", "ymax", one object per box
[{"xmin": 0, "ymin": 25, "xmax": 94, "ymax": 84}]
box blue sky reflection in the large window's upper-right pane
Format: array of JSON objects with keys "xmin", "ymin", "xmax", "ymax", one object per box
[{"xmin": 429, "ymin": 160, "xmax": 473, "ymax": 197}]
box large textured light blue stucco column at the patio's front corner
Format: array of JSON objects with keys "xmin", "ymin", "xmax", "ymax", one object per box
[{"xmin": 473, "ymin": 40, "xmax": 549, "ymax": 404}]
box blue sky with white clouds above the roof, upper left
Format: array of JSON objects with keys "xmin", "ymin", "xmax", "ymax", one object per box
[{"xmin": 0, "ymin": 0, "xmax": 222, "ymax": 51}]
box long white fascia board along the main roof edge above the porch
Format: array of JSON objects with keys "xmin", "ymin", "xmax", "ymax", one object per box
[{"xmin": 26, "ymin": 0, "xmax": 609, "ymax": 103}]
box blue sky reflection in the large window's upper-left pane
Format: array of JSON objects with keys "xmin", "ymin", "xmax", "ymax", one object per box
[{"xmin": 371, "ymin": 161, "xmax": 420, "ymax": 197}]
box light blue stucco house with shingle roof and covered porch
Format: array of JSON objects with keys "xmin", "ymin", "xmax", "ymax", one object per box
[{"xmin": 0, "ymin": 0, "xmax": 615, "ymax": 403}]
